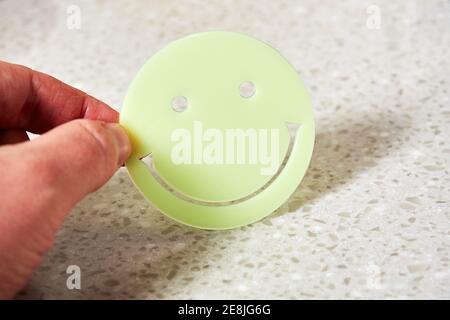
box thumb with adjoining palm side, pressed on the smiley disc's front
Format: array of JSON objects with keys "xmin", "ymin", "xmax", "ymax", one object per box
[{"xmin": 0, "ymin": 120, "xmax": 131, "ymax": 298}]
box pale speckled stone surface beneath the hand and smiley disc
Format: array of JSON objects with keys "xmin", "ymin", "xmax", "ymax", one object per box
[{"xmin": 0, "ymin": 0, "xmax": 450, "ymax": 299}]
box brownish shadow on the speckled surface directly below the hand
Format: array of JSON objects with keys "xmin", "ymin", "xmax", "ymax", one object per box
[{"xmin": 16, "ymin": 174, "xmax": 220, "ymax": 299}]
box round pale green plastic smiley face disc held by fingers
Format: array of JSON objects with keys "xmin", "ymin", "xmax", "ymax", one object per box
[{"xmin": 120, "ymin": 32, "xmax": 314, "ymax": 229}]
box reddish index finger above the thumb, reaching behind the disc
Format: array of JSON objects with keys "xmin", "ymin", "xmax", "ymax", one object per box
[{"xmin": 0, "ymin": 61, "xmax": 119, "ymax": 134}]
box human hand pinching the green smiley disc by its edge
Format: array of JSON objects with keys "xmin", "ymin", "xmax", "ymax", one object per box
[{"xmin": 0, "ymin": 61, "xmax": 131, "ymax": 299}]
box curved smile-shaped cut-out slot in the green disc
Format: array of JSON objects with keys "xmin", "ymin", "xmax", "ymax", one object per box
[{"xmin": 139, "ymin": 122, "xmax": 301, "ymax": 207}]
